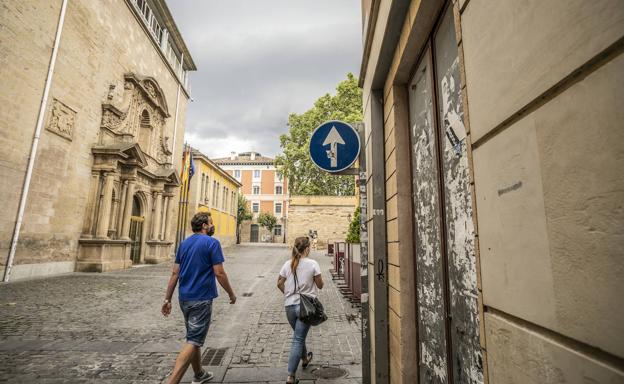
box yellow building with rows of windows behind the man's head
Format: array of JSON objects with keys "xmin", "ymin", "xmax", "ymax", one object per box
[{"xmin": 187, "ymin": 149, "xmax": 241, "ymax": 247}]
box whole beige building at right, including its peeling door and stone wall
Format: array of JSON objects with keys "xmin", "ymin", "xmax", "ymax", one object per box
[{"xmin": 360, "ymin": 0, "xmax": 624, "ymax": 384}]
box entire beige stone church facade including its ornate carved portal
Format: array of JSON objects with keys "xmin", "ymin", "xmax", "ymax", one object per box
[{"xmin": 0, "ymin": 0, "xmax": 196, "ymax": 280}]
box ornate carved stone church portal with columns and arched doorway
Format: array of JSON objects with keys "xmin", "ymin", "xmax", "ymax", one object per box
[{"xmin": 76, "ymin": 74, "xmax": 180, "ymax": 272}]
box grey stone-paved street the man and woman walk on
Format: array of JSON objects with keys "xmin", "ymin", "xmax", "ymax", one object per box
[{"xmin": 0, "ymin": 246, "xmax": 361, "ymax": 384}]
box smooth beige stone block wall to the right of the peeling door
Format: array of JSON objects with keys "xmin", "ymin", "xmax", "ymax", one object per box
[{"xmin": 459, "ymin": 0, "xmax": 624, "ymax": 383}]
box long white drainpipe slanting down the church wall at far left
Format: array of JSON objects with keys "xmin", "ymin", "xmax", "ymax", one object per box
[{"xmin": 3, "ymin": 0, "xmax": 67, "ymax": 282}]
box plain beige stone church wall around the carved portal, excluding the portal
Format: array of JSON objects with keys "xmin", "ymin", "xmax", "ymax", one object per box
[{"xmin": 0, "ymin": 0, "xmax": 187, "ymax": 278}]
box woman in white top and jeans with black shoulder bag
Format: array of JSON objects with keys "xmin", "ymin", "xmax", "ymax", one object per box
[{"xmin": 277, "ymin": 237, "xmax": 323, "ymax": 384}]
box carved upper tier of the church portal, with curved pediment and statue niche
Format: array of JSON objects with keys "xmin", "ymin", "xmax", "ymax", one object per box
[{"xmin": 101, "ymin": 73, "xmax": 172, "ymax": 164}]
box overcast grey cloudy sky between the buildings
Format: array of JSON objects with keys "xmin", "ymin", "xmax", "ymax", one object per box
[{"xmin": 168, "ymin": 0, "xmax": 362, "ymax": 157}]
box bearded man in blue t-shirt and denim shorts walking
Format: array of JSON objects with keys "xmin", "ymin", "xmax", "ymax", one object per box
[{"xmin": 162, "ymin": 212, "xmax": 236, "ymax": 384}]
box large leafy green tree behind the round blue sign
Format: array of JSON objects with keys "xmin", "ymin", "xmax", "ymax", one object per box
[{"xmin": 275, "ymin": 73, "xmax": 363, "ymax": 196}]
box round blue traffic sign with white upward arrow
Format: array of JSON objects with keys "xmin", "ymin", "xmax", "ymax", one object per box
[{"xmin": 310, "ymin": 120, "xmax": 360, "ymax": 172}]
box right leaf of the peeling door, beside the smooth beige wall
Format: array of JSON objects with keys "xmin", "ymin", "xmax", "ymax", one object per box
[{"xmin": 434, "ymin": 8, "xmax": 483, "ymax": 384}]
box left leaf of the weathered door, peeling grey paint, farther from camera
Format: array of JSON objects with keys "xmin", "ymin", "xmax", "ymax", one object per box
[{"xmin": 410, "ymin": 55, "xmax": 448, "ymax": 383}]
